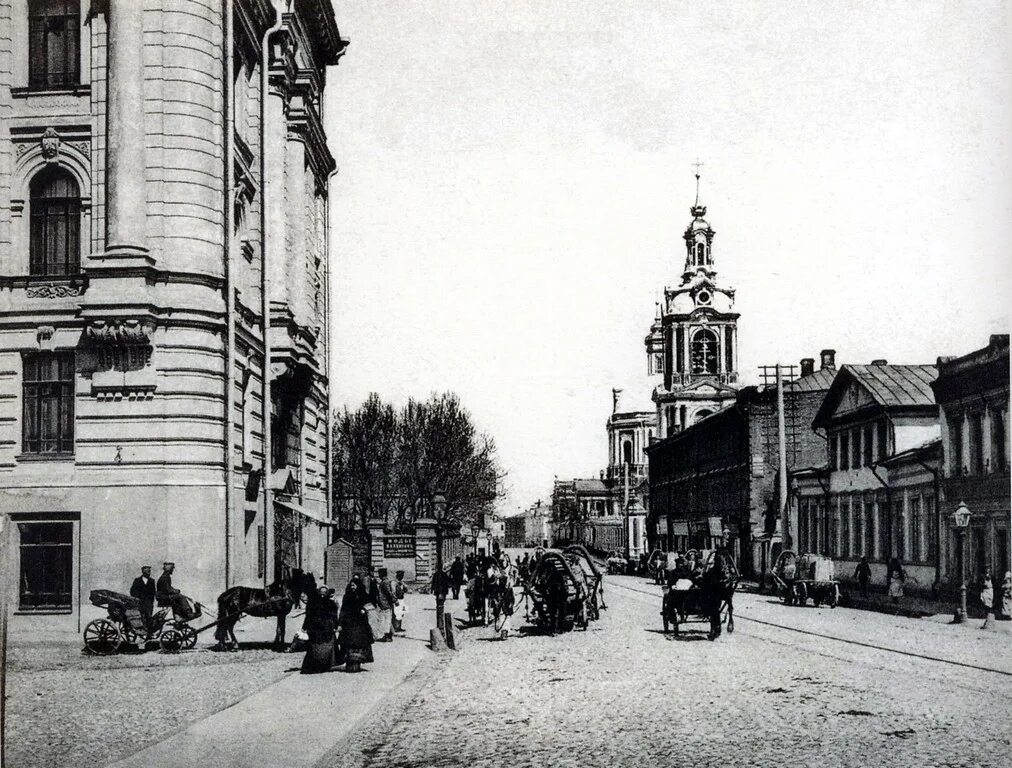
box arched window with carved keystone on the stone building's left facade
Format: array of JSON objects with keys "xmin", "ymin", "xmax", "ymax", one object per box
[{"xmin": 28, "ymin": 168, "xmax": 81, "ymax": 275}]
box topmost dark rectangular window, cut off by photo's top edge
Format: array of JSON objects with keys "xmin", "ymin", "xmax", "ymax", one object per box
[{"xmin": 28, "ymin": 0, "xmax": 81, "ymax": 90}]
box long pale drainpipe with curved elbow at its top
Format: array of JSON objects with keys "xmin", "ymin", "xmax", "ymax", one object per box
[{"xmin": 258, "ymin": 8, "xmax": 282, "ymax": 589}]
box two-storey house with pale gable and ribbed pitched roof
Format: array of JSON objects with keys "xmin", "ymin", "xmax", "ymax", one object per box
[{"xmin": 792, "ymin": 360, "xmax": 940, "ymax": 591}]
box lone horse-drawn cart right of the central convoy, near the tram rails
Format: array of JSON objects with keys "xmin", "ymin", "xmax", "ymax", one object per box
[{"xmin": 661, "ymin": 548, "xmax": 739, "ymax": 639}]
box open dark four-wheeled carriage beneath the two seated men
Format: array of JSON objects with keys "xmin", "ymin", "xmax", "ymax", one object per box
[{"xmin": 84, "ymin": 589, "xmax": 200, "ymax": 656}]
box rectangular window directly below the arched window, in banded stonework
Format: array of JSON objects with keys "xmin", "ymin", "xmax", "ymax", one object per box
[{"xmin": 21, "ymin": 351, "xmax": 74, "ymax": 455}]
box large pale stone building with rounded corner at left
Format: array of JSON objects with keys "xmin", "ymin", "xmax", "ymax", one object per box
[{"xmin": 0, "ymin": 0, "xmax": 345, "ymax": 629}]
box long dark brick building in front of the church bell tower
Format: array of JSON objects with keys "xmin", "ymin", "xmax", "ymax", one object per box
[{"xmin": 647, "ymin": 349, "xmax": 836, "ymax": 575}]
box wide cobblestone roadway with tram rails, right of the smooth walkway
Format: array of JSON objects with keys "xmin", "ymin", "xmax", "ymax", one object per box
[{"xmin": 321, "ymin": 577, "xmax": 1012, "ymax": 768}]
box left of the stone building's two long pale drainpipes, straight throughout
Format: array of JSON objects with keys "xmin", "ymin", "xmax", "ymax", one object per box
[{"xmin": 222, "ymin": 0, "xmax": 236, "ymax": 589}]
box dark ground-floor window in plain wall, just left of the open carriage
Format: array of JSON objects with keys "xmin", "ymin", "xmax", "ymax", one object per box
[{"xmin": 17, "ymin": 521, "xmax": 74, "ymax": 611}]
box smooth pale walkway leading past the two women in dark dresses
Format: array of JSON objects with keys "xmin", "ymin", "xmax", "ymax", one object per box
[{"xmin": 104, "ymin": 594, "xmax": 457, "ymax": 768}]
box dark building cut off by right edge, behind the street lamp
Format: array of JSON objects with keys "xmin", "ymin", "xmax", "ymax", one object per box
[{"xmin": 931, "ymin": 334, "xmax": 1010, "ymax": 586}]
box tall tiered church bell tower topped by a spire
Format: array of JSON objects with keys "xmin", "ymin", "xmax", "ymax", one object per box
[{"xmin": 646, "ymin": 174, "xmax": 739, "ymax": 437}]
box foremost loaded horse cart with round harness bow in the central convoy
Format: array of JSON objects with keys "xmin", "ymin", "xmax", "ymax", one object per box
[{"xmin": 523, "ymin": 549, "xmax": 598, "ymax": 633}]
